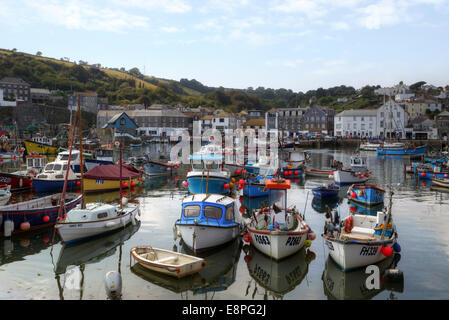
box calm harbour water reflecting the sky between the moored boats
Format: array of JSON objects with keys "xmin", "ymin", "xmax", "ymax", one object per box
[{"xmin": 0, "ymin": 145, "xmax": 449, "ymax": 300}]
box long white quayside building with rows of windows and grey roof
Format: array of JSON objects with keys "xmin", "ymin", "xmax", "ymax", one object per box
[{"xmin": 334, "ymin": 109, "xmax": 378, "ymax": 138}]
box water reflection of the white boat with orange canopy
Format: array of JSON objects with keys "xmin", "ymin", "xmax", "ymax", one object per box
[{"xmin": 244, "ymin": 246, "xmax": 315, "ymax": 300}]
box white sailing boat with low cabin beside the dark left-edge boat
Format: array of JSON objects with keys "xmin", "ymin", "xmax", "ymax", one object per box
[{"xmin": 55, "ymin": 198, "xmax": 140, "ymax": 243}]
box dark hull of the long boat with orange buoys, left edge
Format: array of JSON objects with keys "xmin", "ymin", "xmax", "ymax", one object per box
[{"xmin": 0, "ymin": 195, "xmax": 81, "ymax": 236}]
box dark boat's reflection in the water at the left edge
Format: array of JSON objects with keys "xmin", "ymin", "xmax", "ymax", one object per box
[{"xmin": 0, "ymin": 228, "xmax": 60, "ymax": 265}]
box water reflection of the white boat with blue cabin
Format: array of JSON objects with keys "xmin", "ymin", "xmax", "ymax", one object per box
[{"xmin": 131, "ymin": 238, "xmax": 242, "ymax": 300}]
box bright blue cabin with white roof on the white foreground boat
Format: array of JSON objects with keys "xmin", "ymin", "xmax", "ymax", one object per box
[{"xmin": 179, "ymin": 194, "xmax": 235, "ymax": 227}]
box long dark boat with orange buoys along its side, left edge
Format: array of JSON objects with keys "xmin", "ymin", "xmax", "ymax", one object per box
[{"xmin": 0, "ymin": 193, "xmax": 81, "ymax": 237}]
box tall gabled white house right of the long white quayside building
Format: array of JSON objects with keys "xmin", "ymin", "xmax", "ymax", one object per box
[{"xmin": 377, "ymin": 100, "xmax": 408, "ymax": 138}]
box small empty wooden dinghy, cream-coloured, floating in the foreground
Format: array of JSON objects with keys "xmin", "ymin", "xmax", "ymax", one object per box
[{"xmin": 131, "ymin": 246, "xmax": 206, "ymax": 278}]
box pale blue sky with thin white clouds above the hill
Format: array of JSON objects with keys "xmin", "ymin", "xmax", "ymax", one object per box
[{"xmin": 0, "ymin": 0, "xmax": 449, "ymax": 92}]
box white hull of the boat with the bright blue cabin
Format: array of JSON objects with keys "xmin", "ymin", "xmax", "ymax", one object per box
[{"xmin": 176, "ymin": 223, "xmax": 240, "ymax": 252}]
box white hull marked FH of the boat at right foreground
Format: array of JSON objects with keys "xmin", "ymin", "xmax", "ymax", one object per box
[{"xmin": 325, "ymin": 239, "xmax": 396, "ymax": 271}]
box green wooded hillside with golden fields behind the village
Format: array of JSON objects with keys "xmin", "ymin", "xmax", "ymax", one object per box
[{"xmin": 0, "ymin": 49, "xmax": 449, "ymax": 113}]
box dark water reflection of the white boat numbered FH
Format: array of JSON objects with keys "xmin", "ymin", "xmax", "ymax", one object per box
[{"xmin": 321, "ymin": 253, "xmax": 404, "ymax": 300}]
